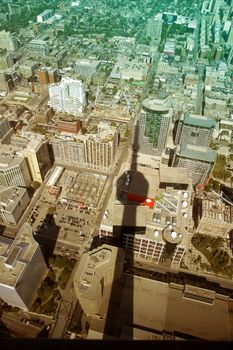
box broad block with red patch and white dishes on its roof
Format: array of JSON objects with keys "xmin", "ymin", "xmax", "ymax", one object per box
[{"xmin": 99, "ymin": 167, "xmax": 192, "ymax": 266}]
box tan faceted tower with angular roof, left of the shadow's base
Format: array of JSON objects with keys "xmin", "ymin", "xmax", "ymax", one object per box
[{"xmin": 74, "ymin": 244, "xmax": 124, "ymax": 317}]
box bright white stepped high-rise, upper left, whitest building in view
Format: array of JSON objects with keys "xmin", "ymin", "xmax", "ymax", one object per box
[{"xmin": 48, "ymin": 78, "xmax": 86, "ymax": 115}]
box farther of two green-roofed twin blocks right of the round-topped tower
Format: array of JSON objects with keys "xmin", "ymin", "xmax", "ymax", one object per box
[{"xmin": 175, "ymin": 112, "xmax": 216, "ymax": 146}]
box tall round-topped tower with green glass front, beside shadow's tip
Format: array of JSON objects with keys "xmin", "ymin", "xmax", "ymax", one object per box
[{"xmin": 134, "ymin": 98, "xmax": 172, "ymax": 156}]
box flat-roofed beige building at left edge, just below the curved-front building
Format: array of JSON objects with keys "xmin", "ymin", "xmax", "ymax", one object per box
[{"xmin": 0, "ymin": 186, "xmax": 30, "ymax": 224}]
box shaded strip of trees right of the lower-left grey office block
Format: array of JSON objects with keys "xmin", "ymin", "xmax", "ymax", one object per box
[{"xmin": 32, "ymin": 255, "xmax": 76, "ymax": 315}]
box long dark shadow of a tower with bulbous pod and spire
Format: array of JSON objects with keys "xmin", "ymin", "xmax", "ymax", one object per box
[{"xmin": 103, "ymin": 122, "xmax": 148, "ymax": 340}]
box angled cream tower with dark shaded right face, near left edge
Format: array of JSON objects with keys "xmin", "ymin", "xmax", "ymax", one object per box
[{"xmin": 11, "ymin": 132, "xmax": 51, "ymax": 183}]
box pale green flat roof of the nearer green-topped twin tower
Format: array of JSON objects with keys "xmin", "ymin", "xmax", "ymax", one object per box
[{"xmin": 177, "ymin": 144, "xmax": 217, "ymax": 163}]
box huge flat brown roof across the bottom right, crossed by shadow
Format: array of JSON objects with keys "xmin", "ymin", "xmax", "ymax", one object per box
[{"xmin": 87, "ymin": 271, "xmax": 232, "ymax": 340}]
